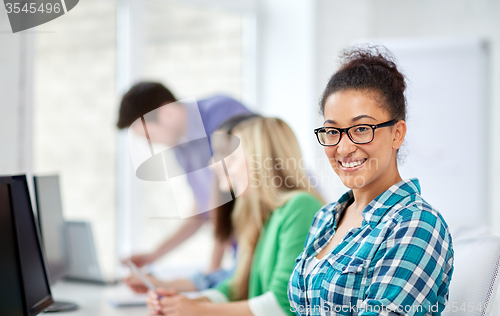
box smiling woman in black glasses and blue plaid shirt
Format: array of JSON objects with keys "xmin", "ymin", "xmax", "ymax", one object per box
[{"xmin": 288, "ymin": 47, "xmax": 453, "ymax": 316}]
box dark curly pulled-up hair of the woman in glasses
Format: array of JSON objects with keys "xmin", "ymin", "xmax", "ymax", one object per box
[{"xmin": 320, "ymin": 45, "xmax": 406, "ymax": 120}]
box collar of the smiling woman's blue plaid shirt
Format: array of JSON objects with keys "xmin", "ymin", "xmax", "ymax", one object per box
[{"xmin": 333, "ymin": 178, "xmax": 421, "ymax": 227}]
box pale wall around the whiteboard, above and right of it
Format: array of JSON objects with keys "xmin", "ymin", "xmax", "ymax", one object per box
[{"xmin": 316, "ymin": 0, "xmax": 500, "ymax": 235}]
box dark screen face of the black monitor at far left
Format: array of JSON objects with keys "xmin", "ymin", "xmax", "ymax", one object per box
[{"xmin": 11, "ymin": 175, "xmax": 53, "ymax": 315}]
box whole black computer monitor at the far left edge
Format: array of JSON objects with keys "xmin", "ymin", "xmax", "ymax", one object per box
[{"xmin": 0, "ymin": 176, "xmax": 53, "ymax": 316}]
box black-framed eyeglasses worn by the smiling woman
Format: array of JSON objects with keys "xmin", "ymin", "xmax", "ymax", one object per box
[{"xmin": 314, "ymin": 119, "xmax": 398, "ymax": 146}]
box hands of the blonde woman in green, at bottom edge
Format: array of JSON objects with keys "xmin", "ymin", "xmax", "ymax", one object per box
[{"xmin": 147, "ymin": 289, "xmax": 209, "ymax": 316}]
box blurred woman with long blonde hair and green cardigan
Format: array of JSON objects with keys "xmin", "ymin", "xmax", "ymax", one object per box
[{"xmin": 148, "ymin": 117, "xmax": 322, "ymax": 316}]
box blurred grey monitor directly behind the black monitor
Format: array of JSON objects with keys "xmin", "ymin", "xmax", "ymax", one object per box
[{"xmin": 35, "ymin": 176, "xmax": 69, "ymax": 284}]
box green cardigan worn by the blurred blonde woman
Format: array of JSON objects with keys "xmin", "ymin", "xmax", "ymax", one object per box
[{"xmin": 217, "ymin": 192, "xmax": 322, "ymax": 315}]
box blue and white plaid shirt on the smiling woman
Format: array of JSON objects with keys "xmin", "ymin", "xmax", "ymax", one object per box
[{"xmin": 288, "ymin": 179, "xmax": 453, "ymax": 316}]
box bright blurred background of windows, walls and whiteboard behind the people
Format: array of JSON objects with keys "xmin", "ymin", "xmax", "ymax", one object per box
[{"xmin": 0, "ymin": 0, "xmax": 500, "ymax": 306}]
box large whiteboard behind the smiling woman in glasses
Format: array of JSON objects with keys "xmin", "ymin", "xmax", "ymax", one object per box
[{"xmin": 372, "ymin": 40, "xmax": 489, "ymax": 228}]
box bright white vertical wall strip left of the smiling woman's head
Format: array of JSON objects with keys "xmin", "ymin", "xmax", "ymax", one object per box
[{"xmin": 257, "ymin": 0, "xmax": 317, "ymax": 168}]
